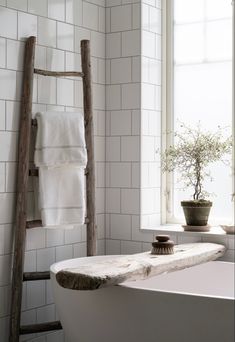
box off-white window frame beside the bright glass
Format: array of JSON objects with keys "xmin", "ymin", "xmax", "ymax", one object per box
[{"xmin": 161, "ymin": 0, "xmax": 235, "ymax": 224}]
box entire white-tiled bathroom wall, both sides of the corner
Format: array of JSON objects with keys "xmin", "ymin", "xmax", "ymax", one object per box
[{"xmin": 0, "ymin": 0, "xmax": 234, "ymax": 342}]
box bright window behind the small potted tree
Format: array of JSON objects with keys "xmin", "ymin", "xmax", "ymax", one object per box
[{"xmin": 162, "ymin": 0, "xmax": 234, "ymax": 224}]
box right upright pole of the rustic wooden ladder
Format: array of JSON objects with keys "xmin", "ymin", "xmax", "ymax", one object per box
[{"xmin": 81, "ymin": 40, "xmax": 97, "ymax": 256}]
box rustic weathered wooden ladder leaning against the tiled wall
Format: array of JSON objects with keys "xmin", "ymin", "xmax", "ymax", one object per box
[{"xmin": 9, "ymin": 37, "xmax": 96, "ymax": 342}]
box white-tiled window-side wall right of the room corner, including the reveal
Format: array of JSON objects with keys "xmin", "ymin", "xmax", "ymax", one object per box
[{"xmin": 106, "ymin": 0, "xmax": 235, "ymax": 262}]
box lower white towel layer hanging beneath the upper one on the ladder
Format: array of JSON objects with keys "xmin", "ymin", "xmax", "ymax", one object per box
[{"xmin": 39, "ymin": 166, "xmax": 85, "ymax": 229}]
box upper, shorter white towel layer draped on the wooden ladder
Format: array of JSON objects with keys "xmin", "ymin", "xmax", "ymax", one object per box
[{"xmin": 34, "ymin": 112, "xmax": 87, "ymax": 166}]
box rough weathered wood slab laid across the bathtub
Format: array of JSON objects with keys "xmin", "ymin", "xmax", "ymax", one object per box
[{"xmin": 56, "ymin": 243, "xmax": 225, "ymax": 290}]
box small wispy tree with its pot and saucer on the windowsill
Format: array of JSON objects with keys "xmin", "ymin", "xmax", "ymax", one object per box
[{"xmin": 161, "ymin": 123, "xmax": 232, "ymax": 230}]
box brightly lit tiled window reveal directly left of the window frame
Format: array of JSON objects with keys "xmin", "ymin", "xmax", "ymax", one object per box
[{"xmin": 140, "ymin": 0, "xmax": 162, "ymax": 229}]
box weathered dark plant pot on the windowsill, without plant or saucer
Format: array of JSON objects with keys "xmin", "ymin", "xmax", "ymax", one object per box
[{"xmin": 181, "ymin": 200, "xmax": 212, "ymax": 226}]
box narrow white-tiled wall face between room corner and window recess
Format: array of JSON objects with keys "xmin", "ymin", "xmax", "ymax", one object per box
[{"xmin": 106, "ymin": 0, "xmax": 144, "ymax": 254}]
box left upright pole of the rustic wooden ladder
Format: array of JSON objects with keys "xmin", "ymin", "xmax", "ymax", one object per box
[{"xmin": 9, "ymin": 37, "xmax": 36, "ymax": 342}]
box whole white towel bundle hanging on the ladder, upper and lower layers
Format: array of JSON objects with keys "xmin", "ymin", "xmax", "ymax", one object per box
[{"xmin": 34, "ymin": 112, "xmax": 87, "ymax": 229}]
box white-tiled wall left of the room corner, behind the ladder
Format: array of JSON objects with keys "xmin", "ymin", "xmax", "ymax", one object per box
[{"xmin": 0, "ymin": 0, "xmax": 105, "ymax": 342}]
